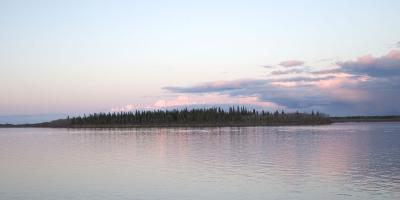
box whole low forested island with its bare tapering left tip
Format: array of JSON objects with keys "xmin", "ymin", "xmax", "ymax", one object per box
[{"xmin": 2, "ymin": 107, "xmax": 332, "ymax": 128}]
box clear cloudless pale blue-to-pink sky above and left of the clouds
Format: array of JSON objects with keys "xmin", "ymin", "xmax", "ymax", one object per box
[{"xmin": 0, "ymin": 0, "xmax": 400, "ymax": 118}]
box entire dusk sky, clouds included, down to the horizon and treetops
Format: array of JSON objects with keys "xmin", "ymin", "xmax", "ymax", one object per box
[{"xmin": 0, "ymin": 0, "xmax": 400, "ymax": 121}]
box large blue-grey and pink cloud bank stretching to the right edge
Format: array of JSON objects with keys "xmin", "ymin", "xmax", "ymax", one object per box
[{"xmin": 164, "ymin": 51, "xmax": 400, "ymax": 115}]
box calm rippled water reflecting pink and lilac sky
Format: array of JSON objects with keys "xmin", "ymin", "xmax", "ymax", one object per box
[{"xmin": 0, "ymin": 123, "xmax": 400, "ymax": 200}]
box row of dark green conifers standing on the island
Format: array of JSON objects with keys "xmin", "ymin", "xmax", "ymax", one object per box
[{"xmin": 66, "ymin": 106, "xmax": 330, "ymax": 125}]
